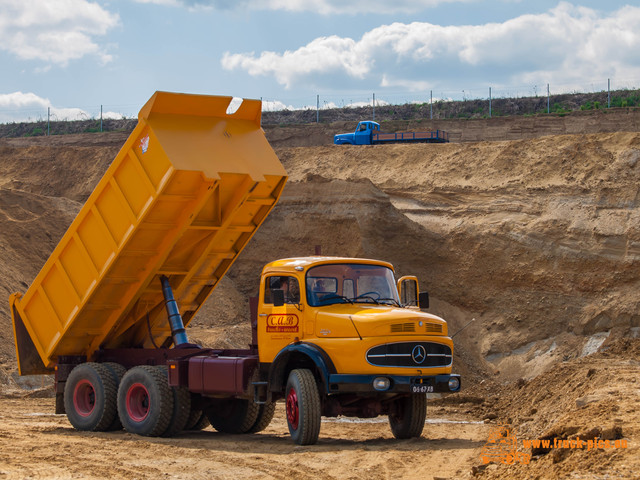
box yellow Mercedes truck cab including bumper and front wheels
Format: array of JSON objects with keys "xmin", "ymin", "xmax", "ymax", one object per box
[{"xmin": 257, "ymin": 257, "xmax": 460, "ymax": 443}]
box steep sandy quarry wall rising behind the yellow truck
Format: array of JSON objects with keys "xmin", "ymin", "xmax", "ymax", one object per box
[{"xmin": 0, "ymin": 126, "xmax": 640, "ymax": 383}]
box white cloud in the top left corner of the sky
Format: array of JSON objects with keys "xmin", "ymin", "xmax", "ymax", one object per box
[{"xmin": 0, "ymin": 0, "xmax": 119, "ymax": 66}]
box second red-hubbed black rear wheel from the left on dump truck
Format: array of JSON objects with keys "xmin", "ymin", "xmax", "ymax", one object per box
[{"xmin": 118, "ymin": 365, "xmax": 173, "ymax": 437}]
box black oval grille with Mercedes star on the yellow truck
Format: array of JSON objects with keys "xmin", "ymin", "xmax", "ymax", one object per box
[{"xmin": 367, "ymin": 342, "xmax": 453, "ymax": 368}]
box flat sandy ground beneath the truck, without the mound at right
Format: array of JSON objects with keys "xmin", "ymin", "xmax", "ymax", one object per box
[{"xmin": 0, "ymin": 398, "xmax": 488, "ymax": 480}]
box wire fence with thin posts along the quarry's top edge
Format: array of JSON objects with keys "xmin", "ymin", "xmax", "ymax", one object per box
[{"xmin": 0, "ymin": 79, "xmax": 640, "ymax": 136}]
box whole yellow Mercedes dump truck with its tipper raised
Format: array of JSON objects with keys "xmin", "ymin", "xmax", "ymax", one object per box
[{"xmin": 10, "ymin": 92, "xmax": 460, "ymax": 445}]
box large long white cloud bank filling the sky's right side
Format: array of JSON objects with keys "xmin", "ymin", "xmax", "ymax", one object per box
[{"xmin": 221, "ymin": 2, "xmax": 640, "ymax": 91}]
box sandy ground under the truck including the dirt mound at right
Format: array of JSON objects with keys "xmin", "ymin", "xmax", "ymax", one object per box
[{"xmin": 0, "ymin": 340, "xmax": 640, "ymax": 480}]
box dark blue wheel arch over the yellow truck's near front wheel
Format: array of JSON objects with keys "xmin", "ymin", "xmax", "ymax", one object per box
[{"xmin": 269, "ymin": 343, "xmax": 336, "ymax": 393}]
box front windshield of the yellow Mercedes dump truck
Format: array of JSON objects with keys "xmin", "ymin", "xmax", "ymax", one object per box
[{"xmin": 306, "ymin": 263, "xmax": 400, "ymax": 307}]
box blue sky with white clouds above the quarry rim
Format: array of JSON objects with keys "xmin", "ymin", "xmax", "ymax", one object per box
[{"xmin": 0, "ymin": 0, "xmax": 640, "ymax": 123}]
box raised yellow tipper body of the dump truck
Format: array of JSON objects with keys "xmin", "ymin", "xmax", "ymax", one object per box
[{"xmin": 10, "ymin": 92, "xmax": 287, "ymax": 375}]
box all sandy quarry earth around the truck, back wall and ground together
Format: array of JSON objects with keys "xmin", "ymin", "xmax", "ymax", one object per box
[{"xmin": 0, "ymin": 120, "xmax": 640, "ymax": 480}]
